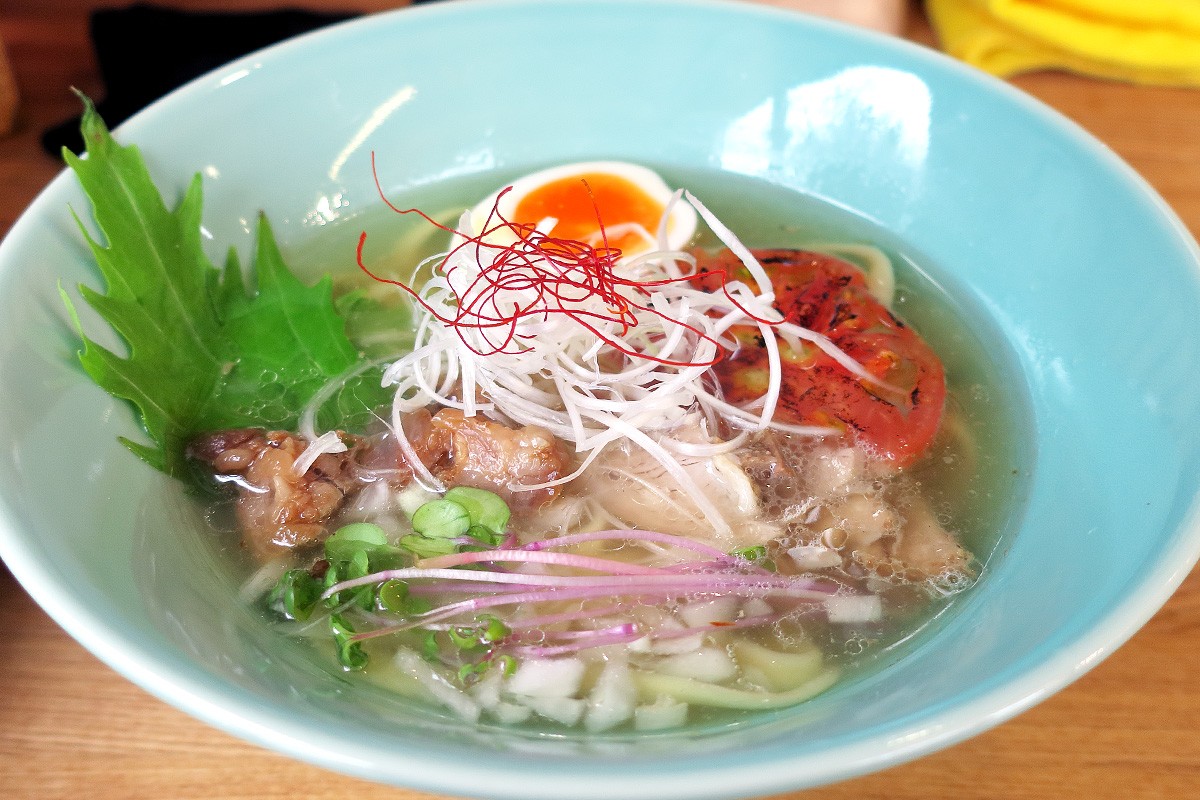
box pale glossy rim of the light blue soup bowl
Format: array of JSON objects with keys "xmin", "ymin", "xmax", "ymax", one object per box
[{"xmin": 0, "ymin": 0, "xmax": 1200, "ymax": 800}]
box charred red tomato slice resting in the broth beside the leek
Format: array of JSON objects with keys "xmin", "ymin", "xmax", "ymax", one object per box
[{"xmin": 697, "ymin": 249, "xmax": 946, "ymax": 467}]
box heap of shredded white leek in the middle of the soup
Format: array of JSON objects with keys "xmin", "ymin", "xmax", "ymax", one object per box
[{"xmin": 374, "ymin": 192, "xmax": 875, "ymax": 533}]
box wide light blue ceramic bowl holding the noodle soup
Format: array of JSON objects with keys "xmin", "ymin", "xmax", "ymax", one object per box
[{"xmin": 0, "ymin": 0, "xmax": 1200, "ymax": 800}]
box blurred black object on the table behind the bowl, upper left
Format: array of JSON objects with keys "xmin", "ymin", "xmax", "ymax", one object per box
[{"xmin": 42, "ymin": 4, "xmax": 356, "ymax": 156}]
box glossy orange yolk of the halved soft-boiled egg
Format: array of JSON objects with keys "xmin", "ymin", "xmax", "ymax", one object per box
[{"xmin": 512, "ymin": 173, "xmax": 664, "ymax": 251}]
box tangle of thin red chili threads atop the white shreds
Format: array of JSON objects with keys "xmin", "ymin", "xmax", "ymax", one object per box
[{"xmin": 355, "ymin": 152, "xmax": 776, "ymax": 367}]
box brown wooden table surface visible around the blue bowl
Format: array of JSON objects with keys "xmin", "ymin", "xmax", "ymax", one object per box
[{"xmin": 0, "ymin": 0, "xmax": 1200, "ymax": 800}]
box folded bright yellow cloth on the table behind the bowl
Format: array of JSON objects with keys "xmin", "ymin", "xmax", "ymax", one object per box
[{"xmin": 926, "ymin": 0, "xmax": 1200, "ymax": 86}]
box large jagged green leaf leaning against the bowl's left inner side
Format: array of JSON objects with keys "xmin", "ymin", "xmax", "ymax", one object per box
[{"xmin": 64, "ymin": 97, "xmax": 388, "ymax": 477}]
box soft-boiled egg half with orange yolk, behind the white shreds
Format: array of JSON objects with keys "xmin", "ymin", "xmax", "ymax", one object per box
[{"xmin": 470, "ymin": 161, "xmax": 696, "ymax": 260}]
